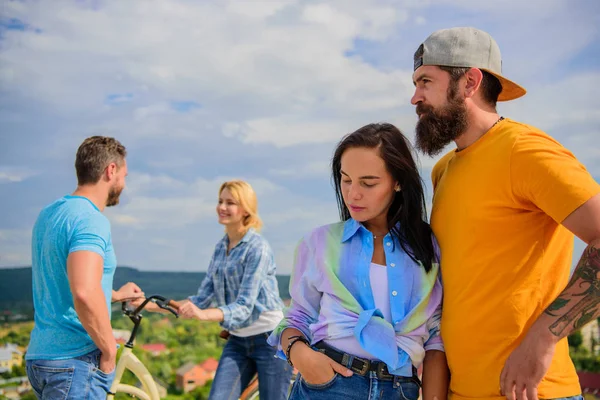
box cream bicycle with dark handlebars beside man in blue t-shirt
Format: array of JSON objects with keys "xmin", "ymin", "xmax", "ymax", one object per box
[{"xmin": 106, "ymin": 295, "xmax": 179, "ymax": 400}]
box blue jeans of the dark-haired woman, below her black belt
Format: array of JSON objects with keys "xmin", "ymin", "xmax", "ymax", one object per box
[{"xmin": 289, "ymin": 361, "xmax": 421, "ymax": 400}]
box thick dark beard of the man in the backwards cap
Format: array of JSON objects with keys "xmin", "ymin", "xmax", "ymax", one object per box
[{"xmin": 415, "ymin": 88, "xmax": 469, "ymax": 157}]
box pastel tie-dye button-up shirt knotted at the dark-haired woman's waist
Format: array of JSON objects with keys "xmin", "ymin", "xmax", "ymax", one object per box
[{"xmin": 269, "ymin": 219, "xmax": 444, "ymax": 376}]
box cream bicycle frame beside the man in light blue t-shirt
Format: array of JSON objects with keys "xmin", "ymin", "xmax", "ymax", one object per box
[{"xmin": 106, "ymin": 346, "xmax": 160, "ymax": 400}]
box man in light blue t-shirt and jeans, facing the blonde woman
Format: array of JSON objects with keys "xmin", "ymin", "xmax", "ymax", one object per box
[{"xmin": 25, "ymin": 136, "xmax": 144, "ymax": 399}]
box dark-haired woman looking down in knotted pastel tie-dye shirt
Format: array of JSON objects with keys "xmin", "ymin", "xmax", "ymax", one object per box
[{"xmin": 269, "ymin": 124, "xmax": 448, "ymax": 400}]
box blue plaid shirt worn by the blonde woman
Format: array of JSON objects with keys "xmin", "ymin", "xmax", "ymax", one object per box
[{"xmin": 189, "ymin": 228, "xmax": 283, "ymax": 330}]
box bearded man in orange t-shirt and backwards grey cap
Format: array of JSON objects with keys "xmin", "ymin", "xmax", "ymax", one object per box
[{"xmin": 412, "ymin": 28, "xmax": 600, "ymax": 400}]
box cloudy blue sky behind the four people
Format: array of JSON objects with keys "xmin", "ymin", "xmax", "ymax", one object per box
[{"xmin": 0, "ymin": 0, "xmax": 600, "ymax": 274}]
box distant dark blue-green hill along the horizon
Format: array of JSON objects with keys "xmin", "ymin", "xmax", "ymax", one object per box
[{"xmin": 0, "ymin": 267, "xmax": 290, "ymax": 312}]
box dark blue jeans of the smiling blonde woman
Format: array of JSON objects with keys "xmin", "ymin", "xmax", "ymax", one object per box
[{"xmin": 208, "ymin": 332, "xmax": 293, "ymax": 400}]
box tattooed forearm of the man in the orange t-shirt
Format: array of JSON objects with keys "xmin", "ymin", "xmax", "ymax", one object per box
[{"xmin": 545, "ymin": 245, "xmax": 600, "ymax": 337}]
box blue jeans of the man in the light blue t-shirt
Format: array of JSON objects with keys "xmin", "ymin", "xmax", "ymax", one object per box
[{"xmin": 26, "ymin": 350, "xmax": 115, "ymax": 400}]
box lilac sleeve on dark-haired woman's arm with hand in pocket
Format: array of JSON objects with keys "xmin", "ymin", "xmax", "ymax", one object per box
[{"xmin": 268, "ymin": 240, "xmax": 322, "ymax": 359}]
